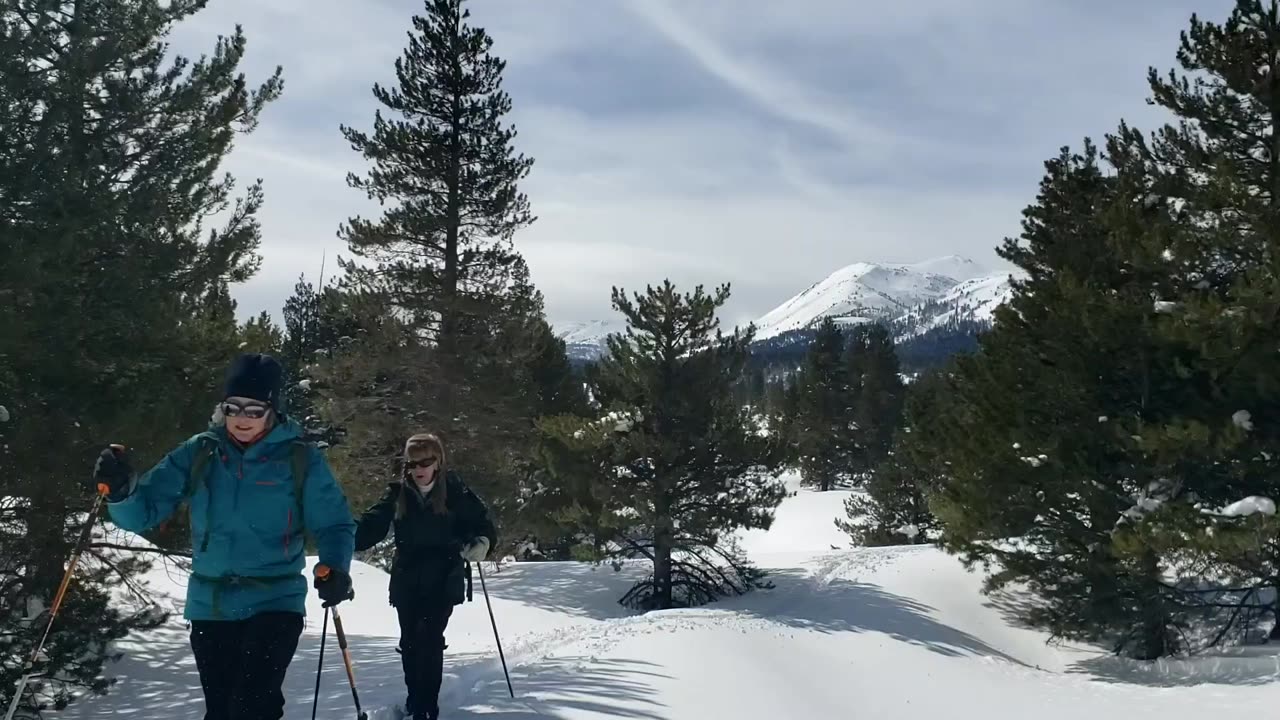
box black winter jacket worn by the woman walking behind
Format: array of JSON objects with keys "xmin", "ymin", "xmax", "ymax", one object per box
[{"xmin": 356, "ymin": 470, "xmax": 498, "ymax": 607}]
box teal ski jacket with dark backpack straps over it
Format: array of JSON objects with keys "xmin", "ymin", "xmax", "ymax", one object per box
[{"xmin": 108, "ymin": 419, "xmax": 356, "ymax": 620}]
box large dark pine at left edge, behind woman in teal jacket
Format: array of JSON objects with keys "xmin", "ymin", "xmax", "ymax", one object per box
[{"xmin": 0, "ymin": 0, "xmax": 280, "ymax": 706}]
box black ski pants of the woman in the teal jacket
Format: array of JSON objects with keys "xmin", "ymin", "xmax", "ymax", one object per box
[{"xmin": 191, "ymin": 612, "xmax": 302, "ymax": 720}]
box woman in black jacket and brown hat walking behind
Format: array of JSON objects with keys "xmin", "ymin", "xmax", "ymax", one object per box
[{"xmin": 356, "ymin": 433, "xmax": 497, "ymax": 720}]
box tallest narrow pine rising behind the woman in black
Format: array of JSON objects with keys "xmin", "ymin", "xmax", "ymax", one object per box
[{"xmin": 330, "ymin": 0, "xmax": 544, "ymax": 538}]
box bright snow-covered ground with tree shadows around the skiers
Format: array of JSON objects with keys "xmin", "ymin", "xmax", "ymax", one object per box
[{"xmin": 49, "ymin": 478, "xmax": 1280, "ymax": 720}]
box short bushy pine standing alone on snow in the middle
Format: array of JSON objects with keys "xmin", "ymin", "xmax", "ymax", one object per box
[{"xmin": 543, "ymin": 282, "xmax": 785, "ymax": 609}]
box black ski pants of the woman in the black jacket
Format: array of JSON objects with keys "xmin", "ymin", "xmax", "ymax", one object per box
[{"xmin": 396, "ymin": 601, "xmax": 453, "ymax": 719}]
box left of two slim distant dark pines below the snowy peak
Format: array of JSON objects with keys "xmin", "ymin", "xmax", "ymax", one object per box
[{"xmin": 792, "ymin": 318, "xmax": 854, "ymax": 491}]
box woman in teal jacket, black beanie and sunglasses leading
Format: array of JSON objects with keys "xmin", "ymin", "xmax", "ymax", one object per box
[{"xmin": 93, "ymin": 354, "xmax": 356, "ymax": 720}]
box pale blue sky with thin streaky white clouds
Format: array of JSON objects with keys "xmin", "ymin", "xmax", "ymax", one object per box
[{"xmin": 172, "ymin": 0, "xmax": 1233, "ymax": 324}]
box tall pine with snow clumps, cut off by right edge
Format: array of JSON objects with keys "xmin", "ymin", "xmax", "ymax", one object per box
[{"xmin": 1107, "ymin": 0, "xmax": 1280, "ymax": 639}]
